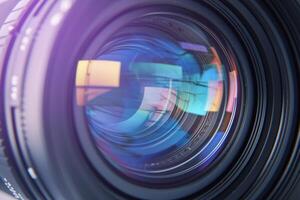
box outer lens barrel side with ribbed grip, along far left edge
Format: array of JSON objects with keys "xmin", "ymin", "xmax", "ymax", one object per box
[{"xmin": 0, "ymin": 0, "xmax": 41, "ymax": 199}]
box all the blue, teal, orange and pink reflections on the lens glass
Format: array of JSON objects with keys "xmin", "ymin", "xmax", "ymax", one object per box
[{"xmin": 76, "ymin": 33, "xmax": 238, "ymax": 184}]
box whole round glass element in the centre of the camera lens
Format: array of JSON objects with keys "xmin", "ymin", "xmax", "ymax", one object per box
[{"xmin": 75, "ymin": 16, "xmax": 238, "ymax": 184}]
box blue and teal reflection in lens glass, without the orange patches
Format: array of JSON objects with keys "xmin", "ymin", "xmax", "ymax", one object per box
[{"xmin": 86, "ymin": 36, "xmax": 222, "ymax": 169}]
